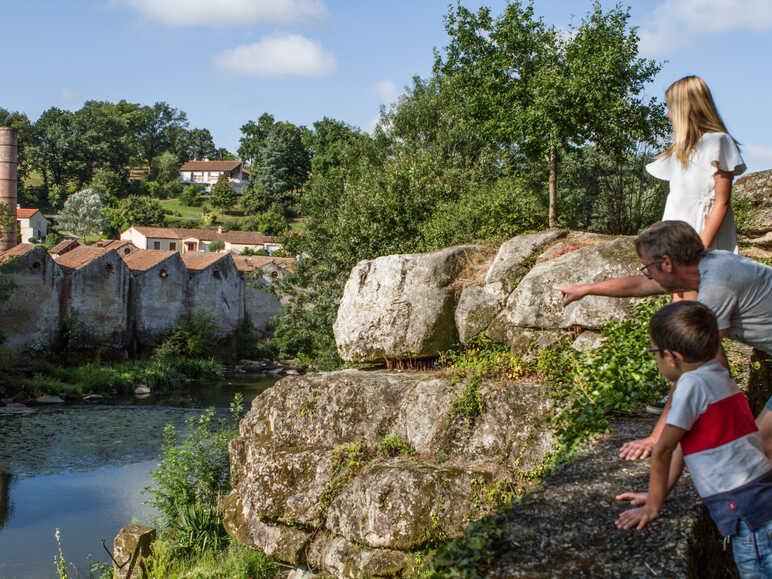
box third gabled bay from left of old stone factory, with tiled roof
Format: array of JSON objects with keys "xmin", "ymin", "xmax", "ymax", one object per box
[{"xmin": 121, "ymin": 249, "xmax": 188, "ymax": 346}]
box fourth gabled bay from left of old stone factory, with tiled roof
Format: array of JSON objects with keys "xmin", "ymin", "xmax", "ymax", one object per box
[{"xmin": 181, "ymin": 252, "xmax": 244, "ymax": 337}]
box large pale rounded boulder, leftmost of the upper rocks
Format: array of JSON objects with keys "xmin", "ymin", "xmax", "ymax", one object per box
[{"xmin": 333, "ymin": 245, "xmax": 478, "ymax": 362}]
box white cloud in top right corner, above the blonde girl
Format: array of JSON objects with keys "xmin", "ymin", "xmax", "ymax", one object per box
[{"xmin": 639, "ymin": 0, "xmax": 772, "ymax": 56}]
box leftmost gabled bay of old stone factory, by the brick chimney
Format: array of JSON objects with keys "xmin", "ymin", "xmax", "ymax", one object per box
[{"xmin": 0, "ymin": 243, "xmax": 62, "ymax": 350}]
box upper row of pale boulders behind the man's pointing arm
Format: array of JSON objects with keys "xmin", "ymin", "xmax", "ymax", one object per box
[{"xmin": 334, "ymin": 231, "xmax": 640, "ymax": 362}]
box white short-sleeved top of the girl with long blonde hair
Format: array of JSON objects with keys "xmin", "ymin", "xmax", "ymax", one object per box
[{"xmin": 646, "ymin": 133, "xmax": 745, "ymax": 253}]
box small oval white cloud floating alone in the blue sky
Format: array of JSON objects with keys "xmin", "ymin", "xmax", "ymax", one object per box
[{"xmin": 214, "ymin": 34, "xmax": 336, "ymax": 76}]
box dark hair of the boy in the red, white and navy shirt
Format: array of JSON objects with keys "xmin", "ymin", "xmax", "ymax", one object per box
[{"xmin": 649, "ymin": 301, "xmax": 720, "ymax": 362}]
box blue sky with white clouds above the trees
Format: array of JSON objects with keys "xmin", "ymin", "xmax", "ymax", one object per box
[{"xmin": 0, "ymin": 0, "xmax": 772, "ymax": 171}]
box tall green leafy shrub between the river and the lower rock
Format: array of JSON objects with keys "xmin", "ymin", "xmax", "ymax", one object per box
[{"xmin": 145, "ymin": 394, "xmax": 244, "ymax": 553}]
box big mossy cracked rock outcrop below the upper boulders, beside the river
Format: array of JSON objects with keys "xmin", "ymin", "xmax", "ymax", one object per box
[{"xmin": 224, "ymin": 370, "xmax": 553, "ymax": 577}]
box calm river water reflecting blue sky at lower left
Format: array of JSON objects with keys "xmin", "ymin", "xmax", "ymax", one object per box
[{"xmin": 0, "ymin": 377, "xmax": 275, "ymax": 579}]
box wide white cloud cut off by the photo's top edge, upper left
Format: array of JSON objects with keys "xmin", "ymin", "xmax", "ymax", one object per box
[{"xmin": 117, "ymin": 0, "xmax": 327, "ymax": 26}]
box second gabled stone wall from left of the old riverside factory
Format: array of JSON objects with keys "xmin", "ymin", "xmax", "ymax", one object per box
[{"xmin": 67, "ymin": 251, "xmax": 131, "ymax": 348}]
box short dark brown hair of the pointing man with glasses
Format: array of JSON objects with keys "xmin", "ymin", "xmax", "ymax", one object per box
[{"xmin": 635, "ymin": 221, "xmax": 705, "ymax": 265}]
